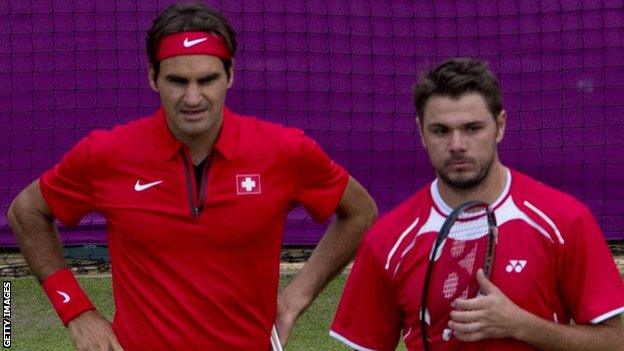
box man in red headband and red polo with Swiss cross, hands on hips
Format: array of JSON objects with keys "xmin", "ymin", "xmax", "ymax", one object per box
[{"xmin": 9, "ymin": 4, "xmax": 376, "ymax": 350}]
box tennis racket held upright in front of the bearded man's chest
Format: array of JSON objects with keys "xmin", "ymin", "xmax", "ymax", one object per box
[{"xmin": 420, "ymin": 201, "xmax": 497, "ymax": 351}]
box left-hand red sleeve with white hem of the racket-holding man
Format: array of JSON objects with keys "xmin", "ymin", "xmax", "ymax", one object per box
[{"xmin": 330, "ymin": 236, "xmax": 402, "ymax": 350}]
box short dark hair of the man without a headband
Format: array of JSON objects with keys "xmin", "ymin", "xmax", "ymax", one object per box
[{"xmin": 412, "ymin": 58, "xmax": 503, "ymax": 121}]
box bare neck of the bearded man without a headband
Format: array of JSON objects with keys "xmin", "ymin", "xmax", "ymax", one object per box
[{"xmin": 438, "ymin": 160, "xmax": 507, "ymax": 208}]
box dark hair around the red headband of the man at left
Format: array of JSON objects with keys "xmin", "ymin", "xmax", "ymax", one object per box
[{"xmin": 147, "ymin": 2, "xmax": 236, "ymax": 80}]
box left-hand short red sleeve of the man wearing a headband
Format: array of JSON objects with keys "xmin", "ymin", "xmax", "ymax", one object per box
[{"xmin": 39, "ymin": 137, "xmax": 95, "ymax": 226}]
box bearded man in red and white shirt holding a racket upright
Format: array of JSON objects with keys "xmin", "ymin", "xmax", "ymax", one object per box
[{"xmin": 331, "ymin": 59, "xmax": 624, "ymax": 351}]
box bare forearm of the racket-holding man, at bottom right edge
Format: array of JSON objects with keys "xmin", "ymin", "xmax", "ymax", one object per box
[{"xmin": 515, "ymin": 315, "xmax": 624, "ymax": 351}]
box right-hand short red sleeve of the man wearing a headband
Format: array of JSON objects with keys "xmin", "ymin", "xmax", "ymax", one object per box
[{"xmin": 294, "ymin": 134, "xmax": 349, "ymax": 222}]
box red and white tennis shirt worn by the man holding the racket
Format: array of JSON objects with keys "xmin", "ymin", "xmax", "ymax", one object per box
[{"xmin": 330, "ymin": 170, "xmax": 624, "ymax": 350}]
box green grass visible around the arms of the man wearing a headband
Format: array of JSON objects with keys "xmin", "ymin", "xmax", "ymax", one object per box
[{"xmin": 11, "ymin": 275, "xmax": 400, "ymax": 351}]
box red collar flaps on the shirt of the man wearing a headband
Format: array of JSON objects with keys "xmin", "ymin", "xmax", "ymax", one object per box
[{"xmin": 153, "ymin": 106, "xmax": 238, "ymax": 160}]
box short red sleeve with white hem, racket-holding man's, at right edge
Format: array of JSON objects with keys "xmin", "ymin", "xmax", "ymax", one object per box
[{"xmin": 560, "ymin": 207, "xmax": 624, "ymax": 324}]
